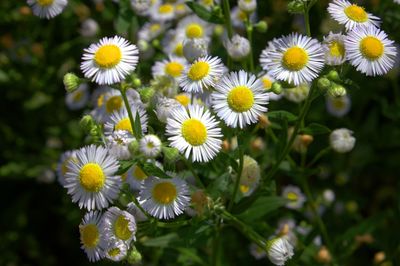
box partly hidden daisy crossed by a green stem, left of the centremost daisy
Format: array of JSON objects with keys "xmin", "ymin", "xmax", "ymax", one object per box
[{"xmin": 104, "ymin": 105, "xmax": 147, "ymax": 136}]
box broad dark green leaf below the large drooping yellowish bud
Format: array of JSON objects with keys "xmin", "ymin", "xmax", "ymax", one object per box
[{"xmin": 238, "ymin": 196, "xmax": 287, "ymax": 221}]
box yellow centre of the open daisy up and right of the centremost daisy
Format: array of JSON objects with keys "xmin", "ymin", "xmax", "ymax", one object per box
[{"xmin": 228, "ymin": 86, "xmax": 254, "ymax": 113}]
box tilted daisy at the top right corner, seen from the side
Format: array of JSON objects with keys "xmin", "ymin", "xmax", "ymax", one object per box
[{"xmin": 328, "ymin": 0, "xmax": 380, "ymax": 30}]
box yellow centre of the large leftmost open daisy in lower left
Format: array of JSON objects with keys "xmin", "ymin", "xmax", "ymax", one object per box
[{"xmin": 79, "ymin": 163, "xmax": 106, "ymax": 192}]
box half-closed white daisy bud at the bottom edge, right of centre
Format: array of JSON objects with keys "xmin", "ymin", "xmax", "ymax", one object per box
[{"xmin": 267, "ymin": 237, "xmax": 294, "ymax": 266}]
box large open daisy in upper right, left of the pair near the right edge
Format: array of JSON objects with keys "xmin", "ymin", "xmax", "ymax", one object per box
[{"xmin": 262, "ymin": 33, "xmax": 324, "ymax": 86}]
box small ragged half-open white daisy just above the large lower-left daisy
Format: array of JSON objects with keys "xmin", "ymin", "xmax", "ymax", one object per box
[{"xmin": 106, "ymin": 130, "xmax": 135, "ymax": 160}]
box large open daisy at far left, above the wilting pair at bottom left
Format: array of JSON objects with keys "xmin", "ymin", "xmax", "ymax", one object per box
[{"xmin": 64, "ymin": 145, "xmax": 122, "ymax": 211}]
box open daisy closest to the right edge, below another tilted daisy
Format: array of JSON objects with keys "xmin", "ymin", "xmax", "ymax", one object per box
[{"xmin": 344, "ymin": 26, "xmax": 397, "ymax": 76}]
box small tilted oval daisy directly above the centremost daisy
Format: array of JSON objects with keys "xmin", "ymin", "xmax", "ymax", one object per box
[{"xmin": 179, "ymin": 56, "xmax": 224, "ymax": 93}]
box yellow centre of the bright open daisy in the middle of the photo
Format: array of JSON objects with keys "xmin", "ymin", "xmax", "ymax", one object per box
[{"xmin": 182, "ymin": 118, "xmax": 207, "ymax": 146}]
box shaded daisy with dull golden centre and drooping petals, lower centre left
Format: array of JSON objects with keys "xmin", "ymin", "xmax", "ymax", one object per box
[{"xmin": 139, "ymin": 176, "xmax": 190, "ymax": 219}]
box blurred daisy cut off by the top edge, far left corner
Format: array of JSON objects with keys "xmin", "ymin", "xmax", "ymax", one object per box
[{"xmin": 27, "ymin": 0, "xmax": 68, "ymax": 19}]
